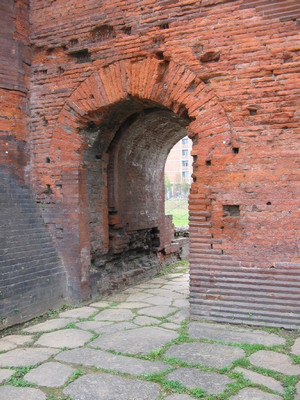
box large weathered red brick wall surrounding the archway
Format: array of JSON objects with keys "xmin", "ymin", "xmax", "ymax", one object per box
[{"xmin": 25, "ymin": 0, "xmax": 300, "ymax": 326}]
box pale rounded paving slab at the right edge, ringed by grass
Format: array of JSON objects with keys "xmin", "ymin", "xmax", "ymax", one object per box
[{"xmin": 249, "ymin": 350, "xmax": 300, "ymax": 376}]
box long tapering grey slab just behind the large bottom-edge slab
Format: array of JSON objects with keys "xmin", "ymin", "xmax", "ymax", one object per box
[{"xmin": 55, "ymin": 348, "xmax": 169, "ymax": 375}]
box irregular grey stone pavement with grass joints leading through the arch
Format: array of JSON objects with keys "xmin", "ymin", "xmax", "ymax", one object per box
[{"xmin": 0, "ymin": 265, "xmax": 300, "ymax": 400}]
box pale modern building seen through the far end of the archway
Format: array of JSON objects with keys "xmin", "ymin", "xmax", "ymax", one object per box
[{"xmin": 165, "ymin": 136, "xmax": 193, "ymax": 199}]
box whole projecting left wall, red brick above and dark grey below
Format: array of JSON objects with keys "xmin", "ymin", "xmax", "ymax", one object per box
[{"xmin": 0, "ymin": 0, "xmax": 66, "ymax": 330}]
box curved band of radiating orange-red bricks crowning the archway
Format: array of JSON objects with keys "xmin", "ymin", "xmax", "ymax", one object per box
[{"xmin": 50, "ymin": 58, "xmax": 232, "ymax": 165}]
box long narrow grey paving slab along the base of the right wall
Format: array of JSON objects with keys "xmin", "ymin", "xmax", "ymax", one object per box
[{"xmin": 189, "ymin": 322, "xmax": 285, "ymax": 346}]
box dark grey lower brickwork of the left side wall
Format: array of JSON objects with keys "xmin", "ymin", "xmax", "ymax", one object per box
[{"xmin": 0, "ymin": 167, "xmax": 66, "ymax": 330}]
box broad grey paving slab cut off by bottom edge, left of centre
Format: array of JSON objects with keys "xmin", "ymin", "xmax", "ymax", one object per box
[{"xmin": 63, "ymin": 374, "xmax": 159, "ymax": 400}]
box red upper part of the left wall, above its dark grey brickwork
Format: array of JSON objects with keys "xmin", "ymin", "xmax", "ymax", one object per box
[{"xmin": 0, "ymin": 0, "xmax": 31, "ymax": 178}]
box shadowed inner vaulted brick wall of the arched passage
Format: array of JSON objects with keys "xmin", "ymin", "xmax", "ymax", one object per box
[{"xmin": 81, "ymin": 98, "xmax": 190, "ymax": 293}]
